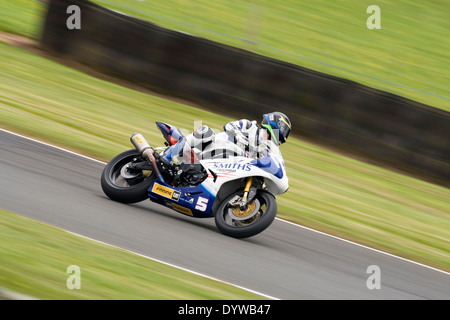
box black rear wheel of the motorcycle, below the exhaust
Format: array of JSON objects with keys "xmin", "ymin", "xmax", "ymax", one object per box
[{"xmin": 101, "ymin": 150, "xmax": 155, "ymax": 203}]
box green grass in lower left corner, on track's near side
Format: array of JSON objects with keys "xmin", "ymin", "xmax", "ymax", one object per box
[{"xmin": 0, "ymin": 209, "xmax": 262, "ymax": 300}]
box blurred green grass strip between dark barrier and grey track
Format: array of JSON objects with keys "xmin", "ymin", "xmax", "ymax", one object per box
[{"xmin": 0, "ymin": 43, "xmax": 450, "ymax": 276}]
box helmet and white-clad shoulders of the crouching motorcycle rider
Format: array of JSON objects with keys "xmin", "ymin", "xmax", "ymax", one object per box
[{"xmin": 223, "ymin": 111, "xmax": 291, "ymax": 157}]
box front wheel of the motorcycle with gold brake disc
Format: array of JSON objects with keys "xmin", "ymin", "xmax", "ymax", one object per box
[{"xmin": 215, "ymin": 190, "xmax": 277, "ymax": 238}]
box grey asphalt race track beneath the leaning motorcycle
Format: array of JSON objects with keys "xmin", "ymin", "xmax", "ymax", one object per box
[{"xmin": 0, "ymin": 131, "xmax": 450, "ymax": 300}]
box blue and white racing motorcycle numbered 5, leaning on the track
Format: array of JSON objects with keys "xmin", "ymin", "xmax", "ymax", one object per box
[{"xmin": 101, "ymin": 122, "xmax": 289, "ymax": 238}]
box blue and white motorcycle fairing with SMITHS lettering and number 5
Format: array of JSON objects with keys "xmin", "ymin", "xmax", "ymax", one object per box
[{"xmin": 148, "ymin": 126, "xmax": 289, "ymax": 218}]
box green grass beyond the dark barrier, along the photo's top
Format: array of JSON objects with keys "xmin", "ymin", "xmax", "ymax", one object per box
[{"xmin": 0, "ymin": 0, "xmax": 450, "ymax": 111}]
